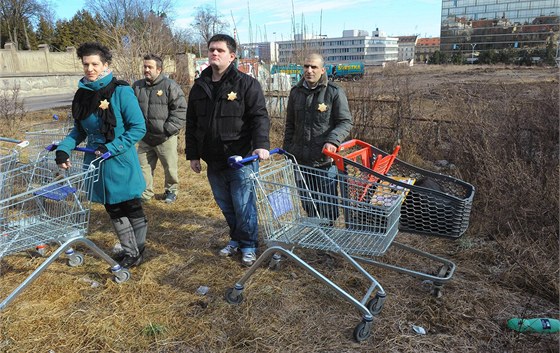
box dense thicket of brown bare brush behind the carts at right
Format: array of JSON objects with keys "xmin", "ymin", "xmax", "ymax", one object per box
[{"xmin": 346, "ymin": 67, "xmax": 559, "ymax": 300}]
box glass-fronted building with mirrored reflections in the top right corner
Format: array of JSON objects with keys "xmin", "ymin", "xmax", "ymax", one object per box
[{"xmin": 440, "ymin": 0, "xmax": 560, "ymax": 56}]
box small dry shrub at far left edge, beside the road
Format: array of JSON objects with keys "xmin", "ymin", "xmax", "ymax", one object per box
[{"xmin": 0, "ymin": 84, "xmax": 25, "ymax": 137}]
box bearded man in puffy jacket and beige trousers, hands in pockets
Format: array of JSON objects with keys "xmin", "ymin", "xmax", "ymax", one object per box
[{"xmin": 133, "ymin": 54, "xmax": 187, "ymax": 203}]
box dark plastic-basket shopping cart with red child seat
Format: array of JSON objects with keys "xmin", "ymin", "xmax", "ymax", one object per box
[{"xmin": 323, "ymin": 140, "xmax": 474, "ymax": 296}]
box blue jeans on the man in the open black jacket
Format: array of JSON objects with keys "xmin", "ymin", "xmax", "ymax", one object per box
[{"xmin": 207, "ymin": 162, "xmax": 259, "ymax": 252}]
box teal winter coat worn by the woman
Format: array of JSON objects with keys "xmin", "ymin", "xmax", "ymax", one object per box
[{"xmin": 58, "ymin": 74, "xmax": 146, "ymax": 204}]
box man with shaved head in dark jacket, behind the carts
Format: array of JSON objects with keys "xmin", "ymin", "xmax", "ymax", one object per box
[{"xmin": 283, "ymin": 54, "xmax": 352, "ymax": 221}]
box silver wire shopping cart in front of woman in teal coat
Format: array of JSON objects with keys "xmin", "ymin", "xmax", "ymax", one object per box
[{"xmin": 0, "ymin": 149, "xmax": 130, "ymax": 310}]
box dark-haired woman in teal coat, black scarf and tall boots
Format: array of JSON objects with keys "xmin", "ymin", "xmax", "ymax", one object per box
[{"xmin": 56, "ymin": 43, "xmax": 148, "ymax": 268}]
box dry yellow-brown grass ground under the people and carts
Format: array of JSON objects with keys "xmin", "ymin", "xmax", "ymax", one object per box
[{"xmin": 0, "ymin": 68, "xmax": 559, "ymax": 353}]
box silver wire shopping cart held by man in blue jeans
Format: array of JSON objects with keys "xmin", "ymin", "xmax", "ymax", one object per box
[{"xmin": 225, "ymin": 149, "xmax": 403, "ymax": 341}]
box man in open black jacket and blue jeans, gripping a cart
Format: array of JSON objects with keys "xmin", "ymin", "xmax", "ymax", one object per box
[{"xmin": 185, "ymin": 34, "xmax": 270, "ymax": 266}]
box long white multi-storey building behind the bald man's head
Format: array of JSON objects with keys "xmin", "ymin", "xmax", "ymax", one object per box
[{"xmin": 278, "ymin": 30, "xmax": 398, "ymax": 66}]
